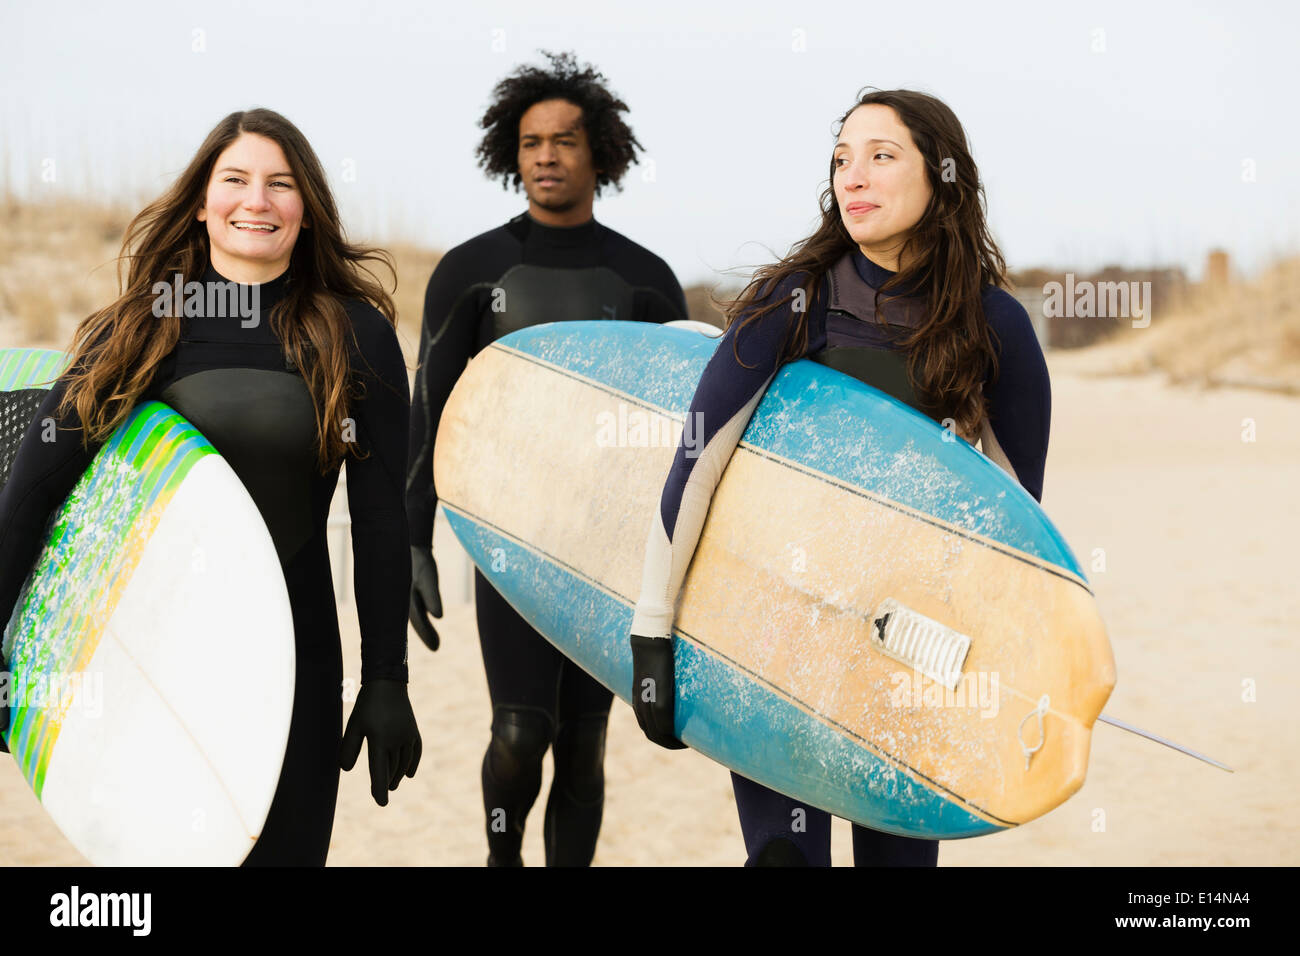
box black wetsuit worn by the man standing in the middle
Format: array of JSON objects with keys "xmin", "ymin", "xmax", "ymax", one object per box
[{"xmin": 407, "ymin": 213, "xmax": 686, "ymax": 866}]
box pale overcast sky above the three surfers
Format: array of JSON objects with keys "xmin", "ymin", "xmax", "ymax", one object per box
[{"xmin": 0, "ymin": 0, "xmax": 1300, "ymax": 285}]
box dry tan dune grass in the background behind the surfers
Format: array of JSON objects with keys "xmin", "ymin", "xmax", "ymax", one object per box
[{"xmin": 0, "ymin": 195, "xmax": 1300, "ymax": 394}]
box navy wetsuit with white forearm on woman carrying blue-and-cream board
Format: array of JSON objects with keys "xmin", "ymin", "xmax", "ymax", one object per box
[{"xmin": 632, "ymin": 248, "xmax": 1052, "ymax": 866}]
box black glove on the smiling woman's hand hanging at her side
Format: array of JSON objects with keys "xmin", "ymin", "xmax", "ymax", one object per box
[{"xmin": 339, "ymin": 679, "xmax": 421, "ymax": 806}]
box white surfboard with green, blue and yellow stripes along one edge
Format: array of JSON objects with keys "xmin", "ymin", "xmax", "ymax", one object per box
[{"xmin": 0, "ymin": 349, "xmax": 294, "ymax": 865}]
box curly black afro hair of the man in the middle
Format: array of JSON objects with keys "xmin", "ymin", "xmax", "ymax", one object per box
[{"xmin": 477, "ymin": 49, "xmax": 645, "ymax": 195}]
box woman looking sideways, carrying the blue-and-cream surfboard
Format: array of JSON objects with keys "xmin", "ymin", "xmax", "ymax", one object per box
[{"xmin": 631, "ymin": 90, "xmax": 1050, "ymax": 866}]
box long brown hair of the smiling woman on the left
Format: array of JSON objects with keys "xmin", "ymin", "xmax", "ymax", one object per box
[{"xmin": 59, "ymin": 109, "xmax": 397, "ymax": 471}]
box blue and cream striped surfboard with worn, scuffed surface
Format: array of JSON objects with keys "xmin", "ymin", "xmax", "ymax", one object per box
[{"xmin": 434, "ymin": 321, "xmax": 1114, "ymax": 839}]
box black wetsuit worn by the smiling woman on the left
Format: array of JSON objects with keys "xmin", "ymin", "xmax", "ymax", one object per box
[{"xmin": 0, "ymin": 268, "xmax": 411, "ymax": 866}]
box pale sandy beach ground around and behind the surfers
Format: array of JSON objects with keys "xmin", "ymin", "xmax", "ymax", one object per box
[{"xmin": 0, "ymin": 354, "xmax": 1300, "ymax": 866}]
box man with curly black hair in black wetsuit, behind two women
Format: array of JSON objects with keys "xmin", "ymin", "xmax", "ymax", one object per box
[{"xmin": 407, "ymin": 53, "xmax": 686, "ymax": 866}]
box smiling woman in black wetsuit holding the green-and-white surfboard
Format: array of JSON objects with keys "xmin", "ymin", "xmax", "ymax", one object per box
[{"xmin": 0, "ymin": 109, "xmax": 420, "ymax": 865}]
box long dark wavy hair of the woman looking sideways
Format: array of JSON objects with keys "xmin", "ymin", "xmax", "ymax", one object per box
[{"xmin": 724, "ymin": 90, "xmax": 1006, "ymax": 434}]
